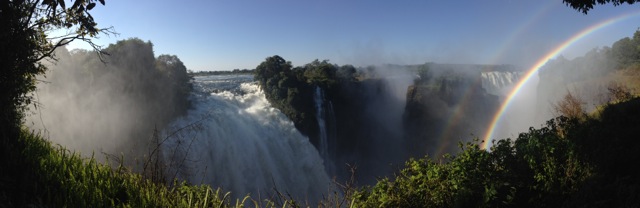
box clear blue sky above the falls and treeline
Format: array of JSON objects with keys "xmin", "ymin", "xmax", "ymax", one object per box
[{"xmin": 62, "ymin": 0, "xmax": 640, "ymax": 71}]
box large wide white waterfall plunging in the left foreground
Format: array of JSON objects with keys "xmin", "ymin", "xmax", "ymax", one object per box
[{"xmin": 163, "ymin": 75, "xmax": 330, "ymax": 201}]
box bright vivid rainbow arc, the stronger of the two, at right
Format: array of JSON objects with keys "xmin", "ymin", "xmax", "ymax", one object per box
[{"xmin": 482, "ymin": 12, "xmax": 640, "ymax": 149}]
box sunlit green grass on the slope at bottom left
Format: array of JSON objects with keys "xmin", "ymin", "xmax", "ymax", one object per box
[{"xmin": 12, "ymin": 130, "xmax": 251, "ymax": 207}]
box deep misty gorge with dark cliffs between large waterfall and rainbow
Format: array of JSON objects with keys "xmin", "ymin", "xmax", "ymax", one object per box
[{"xmin": 255, "ymin": 56, "xmax": 520, "ymax": 184}]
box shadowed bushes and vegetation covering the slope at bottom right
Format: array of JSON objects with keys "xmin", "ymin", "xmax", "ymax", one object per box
[{"xmin": 354, "ymin": 95, "xmax": 640, "ymax": 207}]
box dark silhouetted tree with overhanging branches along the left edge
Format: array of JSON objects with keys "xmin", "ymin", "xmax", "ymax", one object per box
[{"xmin": 0, "ymin": 0, "xmax": 110, "ymax": 207}]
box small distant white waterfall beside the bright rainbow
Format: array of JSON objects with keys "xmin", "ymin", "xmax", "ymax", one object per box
[{"xmin": 481, "ymin": 71, "xmax": 520, "ymax": 96}]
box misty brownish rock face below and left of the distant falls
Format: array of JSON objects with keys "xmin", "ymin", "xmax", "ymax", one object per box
[{"xmin": 404, "ymin": 76, "xmax": 500, "ymax": 157}]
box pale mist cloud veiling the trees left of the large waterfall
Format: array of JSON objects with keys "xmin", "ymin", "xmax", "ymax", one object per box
[{"xmin": 26, "ymin": 39, "xmax": 189, "ymax": 171}]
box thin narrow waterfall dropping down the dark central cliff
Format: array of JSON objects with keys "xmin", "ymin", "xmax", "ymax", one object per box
[{"xmin": 313, "ymin": 86, "xmax": 335, "ymax": 175}]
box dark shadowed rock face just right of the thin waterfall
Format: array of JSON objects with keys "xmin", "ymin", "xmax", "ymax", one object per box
[{"xmin": 328, "ymin": 79, "xmax": 407, "ymax": 184}]
